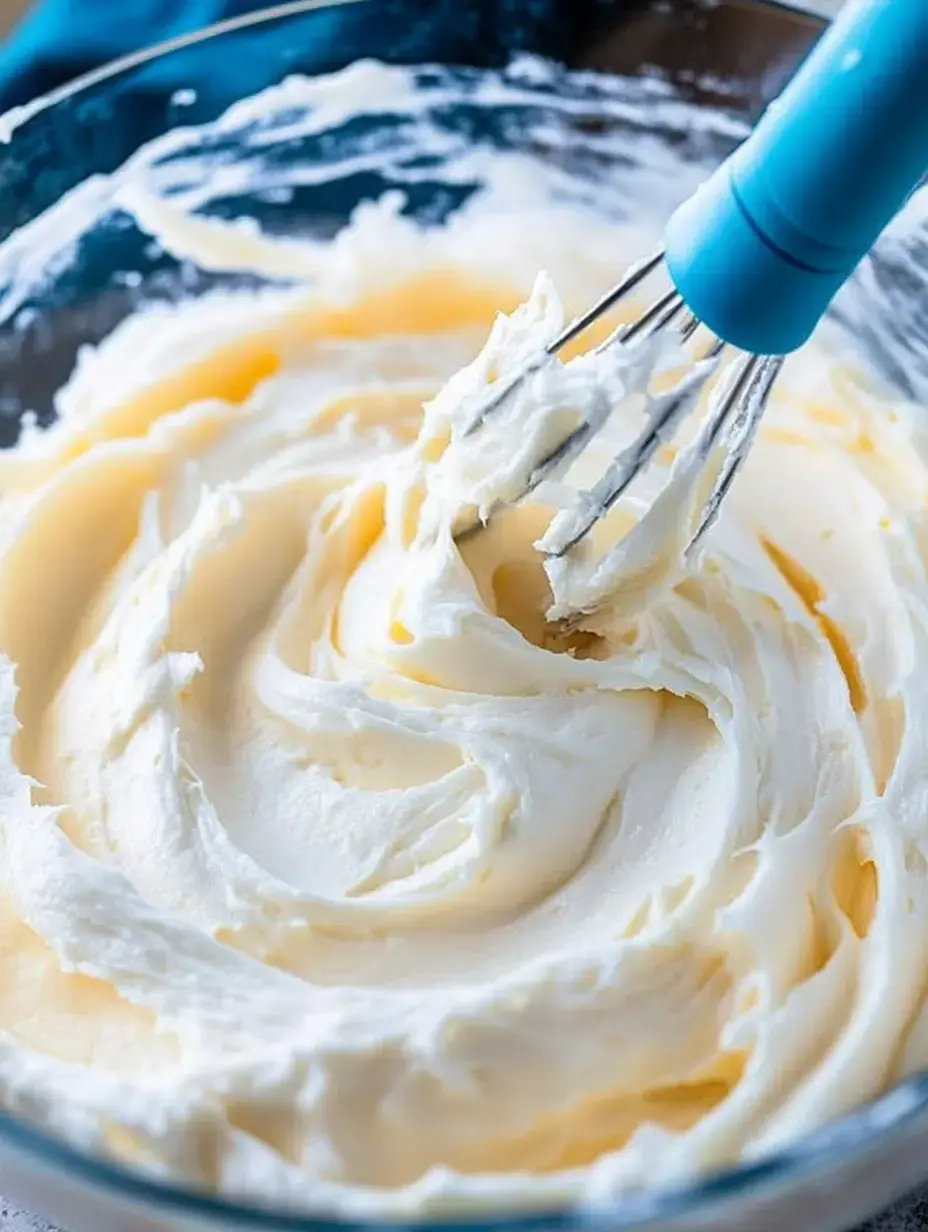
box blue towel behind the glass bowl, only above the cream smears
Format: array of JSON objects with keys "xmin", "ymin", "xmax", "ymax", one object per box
[{"xmin": 0, "ymin": 0, "xmax": 608, "ymax": 240}]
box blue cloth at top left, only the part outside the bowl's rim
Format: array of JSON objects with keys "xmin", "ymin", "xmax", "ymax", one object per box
[{"xmin": 0, "ymin": 0, "xmax": 285, "ymax": 111}]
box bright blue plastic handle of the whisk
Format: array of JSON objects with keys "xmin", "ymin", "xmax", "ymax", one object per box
[{"xmin": 665, "ymin": 0, "xmax": 928, "ymax": 355}]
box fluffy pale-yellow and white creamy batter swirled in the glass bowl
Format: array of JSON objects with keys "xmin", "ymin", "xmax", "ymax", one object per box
[{"xmin": 0, "ymin": 55, "xmax": 928, "ymax": 1214}]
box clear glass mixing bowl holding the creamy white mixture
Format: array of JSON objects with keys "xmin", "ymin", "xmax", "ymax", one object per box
[{"xmin": 0, "ymin": 0, "xmax": 928, "ymax": 1232}]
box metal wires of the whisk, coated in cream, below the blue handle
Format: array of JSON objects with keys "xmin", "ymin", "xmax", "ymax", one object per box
[{"xmin": 455, "ymin": 251, "xmax": 784, "ymax": 557}]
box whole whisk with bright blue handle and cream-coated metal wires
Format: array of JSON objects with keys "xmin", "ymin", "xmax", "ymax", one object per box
[{"xmin": 465, "ymin": 0, "xmax": 928, "ymax": 557}]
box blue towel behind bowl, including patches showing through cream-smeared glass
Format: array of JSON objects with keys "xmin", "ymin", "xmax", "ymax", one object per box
[{"xmin": 0, "ymin": 0, "xmax": 623, "ymax": 438}]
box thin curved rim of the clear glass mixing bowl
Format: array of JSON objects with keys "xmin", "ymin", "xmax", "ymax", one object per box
[{"xmin": 0, "ymin": 0, "xmax": 928, "ymax": 1232}]
